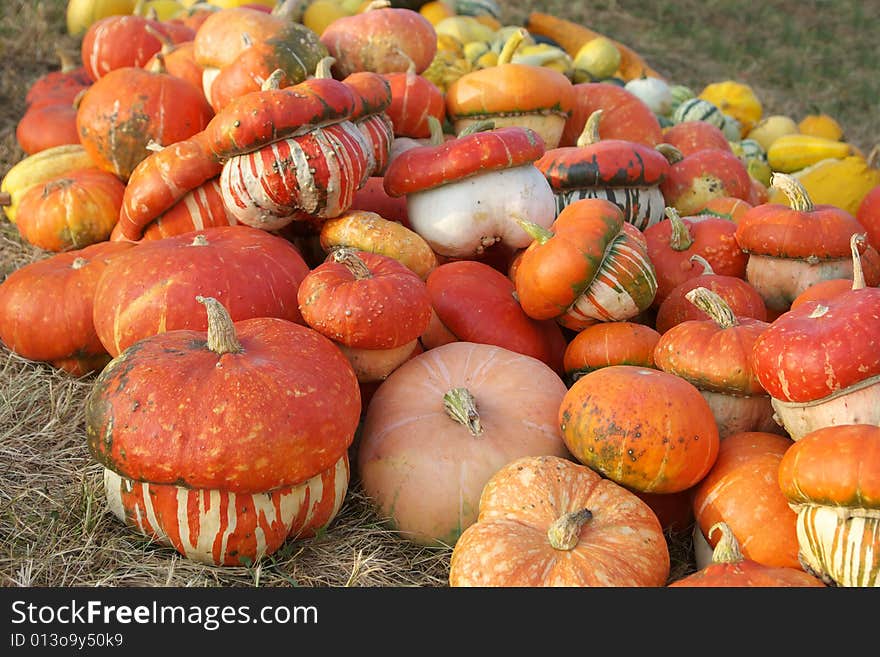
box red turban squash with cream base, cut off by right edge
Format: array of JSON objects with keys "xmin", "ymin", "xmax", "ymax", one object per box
[{"xmin": 752, "ymin": 252, "xmax": 880, "ymax": 440}]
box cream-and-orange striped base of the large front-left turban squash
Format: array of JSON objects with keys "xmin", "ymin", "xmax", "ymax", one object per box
[{"xmin": 104, "ymin": 453, "xmax": 349, "ymax": 566}]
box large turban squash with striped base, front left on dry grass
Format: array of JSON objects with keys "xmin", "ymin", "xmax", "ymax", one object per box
[{"xmin": 86, "ymin": 296, "xmax": 360, "ymax": 565}]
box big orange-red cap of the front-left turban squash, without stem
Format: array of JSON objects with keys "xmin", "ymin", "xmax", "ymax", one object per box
[{"xmin": 86, "ymin": 317, "xmax": 360, "ymax": 493}]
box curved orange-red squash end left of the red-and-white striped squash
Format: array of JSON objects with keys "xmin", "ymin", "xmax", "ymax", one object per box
[{"xmin": 118, "ymin": 132, "xmax": 223, "ymax": 240}]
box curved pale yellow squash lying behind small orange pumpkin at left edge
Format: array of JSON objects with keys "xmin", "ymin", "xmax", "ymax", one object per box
[{"xmin": 0, "ymin": 144, "xmax": 95, "ymax": 223}]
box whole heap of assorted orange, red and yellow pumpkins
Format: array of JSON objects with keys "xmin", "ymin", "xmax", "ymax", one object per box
[{"xmin": 0, "ymin": 0, "xmax": 880, "ymax": 586}]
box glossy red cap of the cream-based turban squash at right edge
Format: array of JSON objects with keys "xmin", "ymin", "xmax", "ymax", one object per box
[{"xmin": 752, "ymin": 288, "xmax": 880, "ymax": 402}]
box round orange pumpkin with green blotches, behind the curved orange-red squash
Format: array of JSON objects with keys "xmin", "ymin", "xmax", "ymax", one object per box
[{"xmin": 76, "ymin": 66, "xmax": 214, "ymax": 181}]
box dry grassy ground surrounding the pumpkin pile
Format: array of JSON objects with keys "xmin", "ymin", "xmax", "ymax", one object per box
[{"xmin": 0, "ymin": 0, "xmax": 880, "ymax": 586}]
